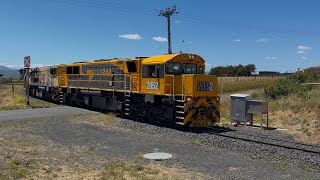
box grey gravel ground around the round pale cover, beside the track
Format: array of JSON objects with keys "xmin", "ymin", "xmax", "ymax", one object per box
[{"xmin": 37, "ymin": 119, "xmax": 320, "ymax": 179}]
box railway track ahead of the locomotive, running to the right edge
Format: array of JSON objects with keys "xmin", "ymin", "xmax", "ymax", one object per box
[{"xmin": 196, "ymin": 127, "xmax": 320, "ymax": 155}]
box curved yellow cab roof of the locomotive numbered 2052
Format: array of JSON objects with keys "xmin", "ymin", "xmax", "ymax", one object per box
[{"xmin": 143, "ymin": 53, "xmax": 204, "ymax": 64}]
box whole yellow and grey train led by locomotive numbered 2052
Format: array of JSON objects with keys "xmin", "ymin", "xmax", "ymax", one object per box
[{"xmin": 29, "ymin": 53, "xmax": 220, "ymax": 127}]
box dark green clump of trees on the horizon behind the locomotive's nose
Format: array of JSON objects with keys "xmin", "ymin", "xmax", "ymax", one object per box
[{"xmin": 209, "ymin": 64, "xmax": 256, "ymax": 76}]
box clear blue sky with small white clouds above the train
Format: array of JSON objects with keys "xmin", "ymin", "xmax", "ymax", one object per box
[{"xmin": 0, "ymin": 0, "xmax": 320, "ymax": 72}]
